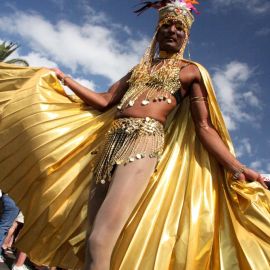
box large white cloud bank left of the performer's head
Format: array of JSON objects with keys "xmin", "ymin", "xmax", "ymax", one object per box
[{"xmin": 0, "ymin": 12, "xmax": 148, "ymax": 81}]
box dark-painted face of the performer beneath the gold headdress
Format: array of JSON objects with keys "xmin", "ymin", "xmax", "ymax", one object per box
[{"xmin": 157, "ymin": 21, "xmax": 185, "ymax": 53}]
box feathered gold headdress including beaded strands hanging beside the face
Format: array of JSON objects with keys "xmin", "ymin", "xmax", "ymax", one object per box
[{"xmin": 134, "ymin": 0, "xmax": 199, "ymax": 63}]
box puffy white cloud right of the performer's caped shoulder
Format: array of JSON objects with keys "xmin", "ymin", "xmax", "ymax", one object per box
[{"xmin": 213, "ymin": 61, "xmax": 260, "ymax": 130}]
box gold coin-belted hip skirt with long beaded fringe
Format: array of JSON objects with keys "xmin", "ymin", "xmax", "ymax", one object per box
[{"xmin": 94, "ymin": 117, "xmax": 164, "ymax": 184}]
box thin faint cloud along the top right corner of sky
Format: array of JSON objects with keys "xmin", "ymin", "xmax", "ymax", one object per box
[{"xmin": 211, "ymin": 0, "xmax": 270, "ymax": 14}]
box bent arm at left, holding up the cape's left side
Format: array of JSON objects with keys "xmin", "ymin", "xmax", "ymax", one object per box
[{"xmin": 51, "ymin": 68, "xmax": 131, "ymax": 111}]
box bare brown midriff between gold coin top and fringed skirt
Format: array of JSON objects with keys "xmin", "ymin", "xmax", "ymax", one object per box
[{"xmin": 115, "ymin": 90, "xmax": 177, "ymax": 125}]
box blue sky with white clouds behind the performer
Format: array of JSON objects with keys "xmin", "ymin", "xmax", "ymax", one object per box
[{"xmin": 0, "ymin": 0, "xmax": 270, "ymax": 173}]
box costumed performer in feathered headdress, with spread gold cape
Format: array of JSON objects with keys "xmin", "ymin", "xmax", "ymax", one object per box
[{"xmin": 0, "ymin": 0, "xmax": 270, "ymax": 270}]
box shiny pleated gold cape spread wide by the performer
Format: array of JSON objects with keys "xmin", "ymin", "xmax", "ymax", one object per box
[{"xmin": 0, "ymin": 64, "xmax": 270, "ymax": 270}]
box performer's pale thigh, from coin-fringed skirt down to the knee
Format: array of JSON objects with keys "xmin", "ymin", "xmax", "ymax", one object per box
[{"xmin": 94, "ymin": 157, "xmax": 157, "ymax": 231}]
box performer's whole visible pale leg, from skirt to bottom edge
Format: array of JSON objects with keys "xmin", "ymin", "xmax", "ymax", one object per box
[{"xmin": 85, "ymin": 157, "xmax": 157, "ymax": 270}]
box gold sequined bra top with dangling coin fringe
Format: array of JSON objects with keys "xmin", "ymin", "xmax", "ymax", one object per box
[{"xmin": 117, "ymin": 59, "xmax": 184, "ymax": 110}]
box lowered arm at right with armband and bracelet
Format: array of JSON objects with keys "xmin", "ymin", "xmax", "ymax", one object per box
[{"xmin": 189, "ymin": 66, "xmax": 267, "ymax": 188}]
